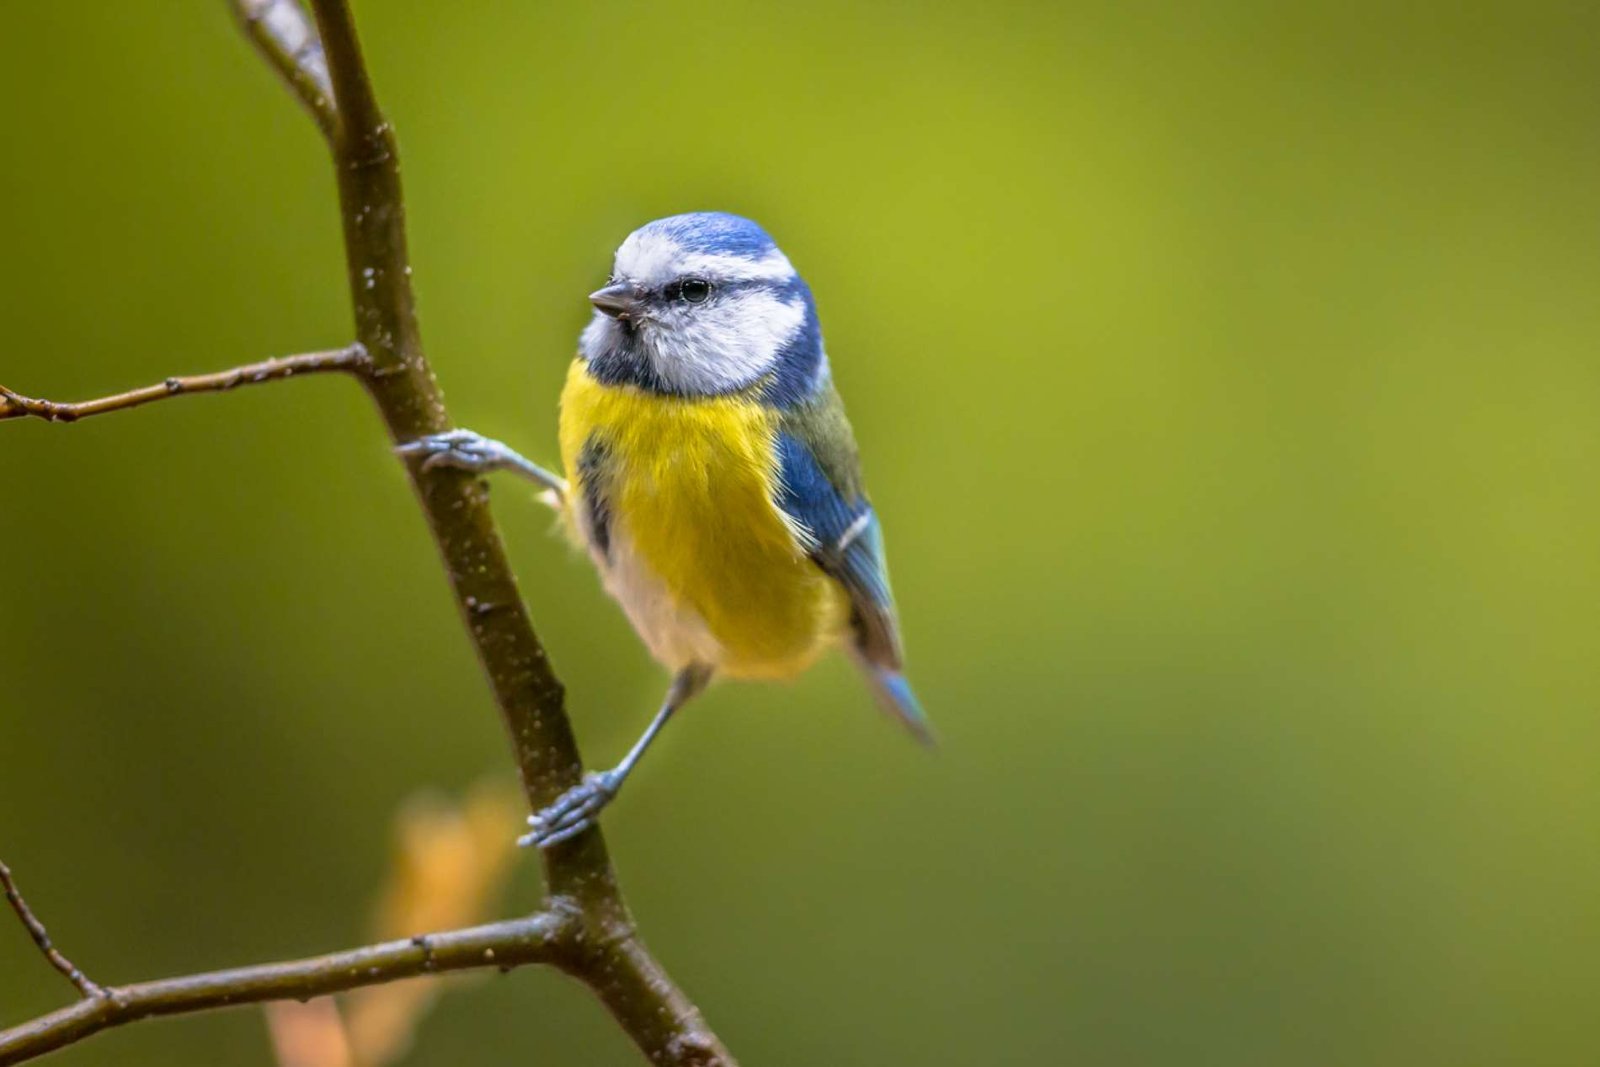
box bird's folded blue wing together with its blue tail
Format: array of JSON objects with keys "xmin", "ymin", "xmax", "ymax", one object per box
[{"xmin": 776, "ymin": 430, "xmax": 933, "ymax": 742}]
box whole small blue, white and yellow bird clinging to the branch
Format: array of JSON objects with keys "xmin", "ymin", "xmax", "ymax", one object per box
[{"xmin": 402, "ymin": 211, "xmax": 931, "ymax": 848}]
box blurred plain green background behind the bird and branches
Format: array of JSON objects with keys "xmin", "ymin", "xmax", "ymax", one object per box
[{"xmin": 0, "ymin": 0, "xmax": 1600, "ymax": 1067}]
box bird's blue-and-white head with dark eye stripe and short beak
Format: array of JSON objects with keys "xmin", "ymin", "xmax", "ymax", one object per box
[{"xmin": 581, "ymin": 211, "xmax": 822, "ymax": 400}]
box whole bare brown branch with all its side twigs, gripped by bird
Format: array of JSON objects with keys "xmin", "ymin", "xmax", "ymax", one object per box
[{"xmin": 0, "ymin": 0, "xmax": 736, "ymax": 1067}]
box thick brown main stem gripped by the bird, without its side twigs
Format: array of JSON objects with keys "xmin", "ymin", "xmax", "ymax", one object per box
[{"xmin": 292, "ymin": 8, "xmax": 734, "ymax": 1067}]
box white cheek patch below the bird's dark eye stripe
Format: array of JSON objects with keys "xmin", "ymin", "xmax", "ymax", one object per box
[{"xmin": 643, "ymin": 290, "xmax": 805, "ymax": 395}]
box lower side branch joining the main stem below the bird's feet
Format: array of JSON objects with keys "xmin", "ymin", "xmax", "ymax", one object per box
[{"xmin": 0, "ymin": 912, "xmax": 576, "ymax": 1067}]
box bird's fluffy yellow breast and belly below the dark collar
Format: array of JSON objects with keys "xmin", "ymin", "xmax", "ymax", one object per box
[{"xmin": 562, "ymin": 360, "xmax": 848, "ymax": 677}]
